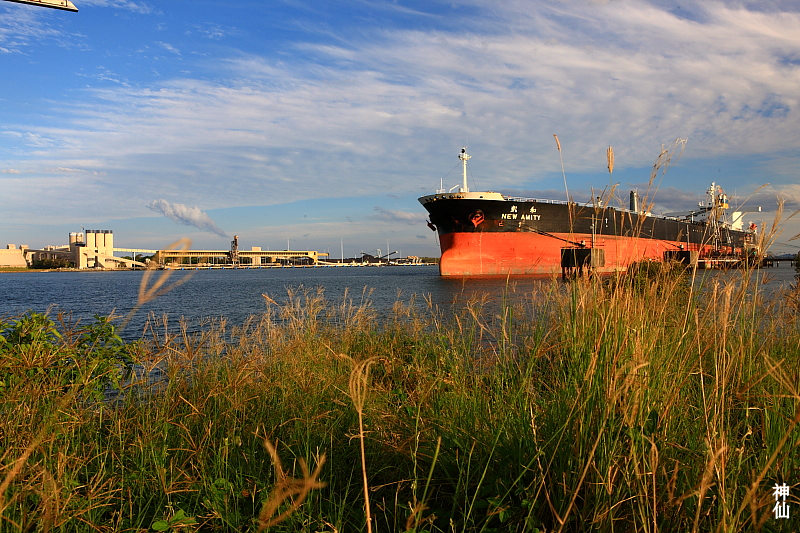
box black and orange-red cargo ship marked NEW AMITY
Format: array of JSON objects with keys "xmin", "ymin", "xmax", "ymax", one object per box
[{"xmin": 419, "ymin": 148, "xmax": 757, "ymax": 277}]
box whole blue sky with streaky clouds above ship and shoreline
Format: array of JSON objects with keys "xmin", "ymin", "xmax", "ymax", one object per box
[{"xmin": 0, "ymin": 0, "xmax": 800, "ymax": 256}]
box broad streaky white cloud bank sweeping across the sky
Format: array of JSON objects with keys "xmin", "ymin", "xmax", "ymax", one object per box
[{"xmin": 0, "ymin": 0, "xmax": 800, "ymax": 249}]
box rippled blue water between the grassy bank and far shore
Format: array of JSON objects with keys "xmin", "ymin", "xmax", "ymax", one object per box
[{"xmin": 0, "ymin": 264, "xmax": 795, "ymax": 338}]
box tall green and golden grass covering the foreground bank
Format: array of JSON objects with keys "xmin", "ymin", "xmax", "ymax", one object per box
[{"xmin": 0, "ymin": 264, "xmax": 800, "ymax": 532}]
